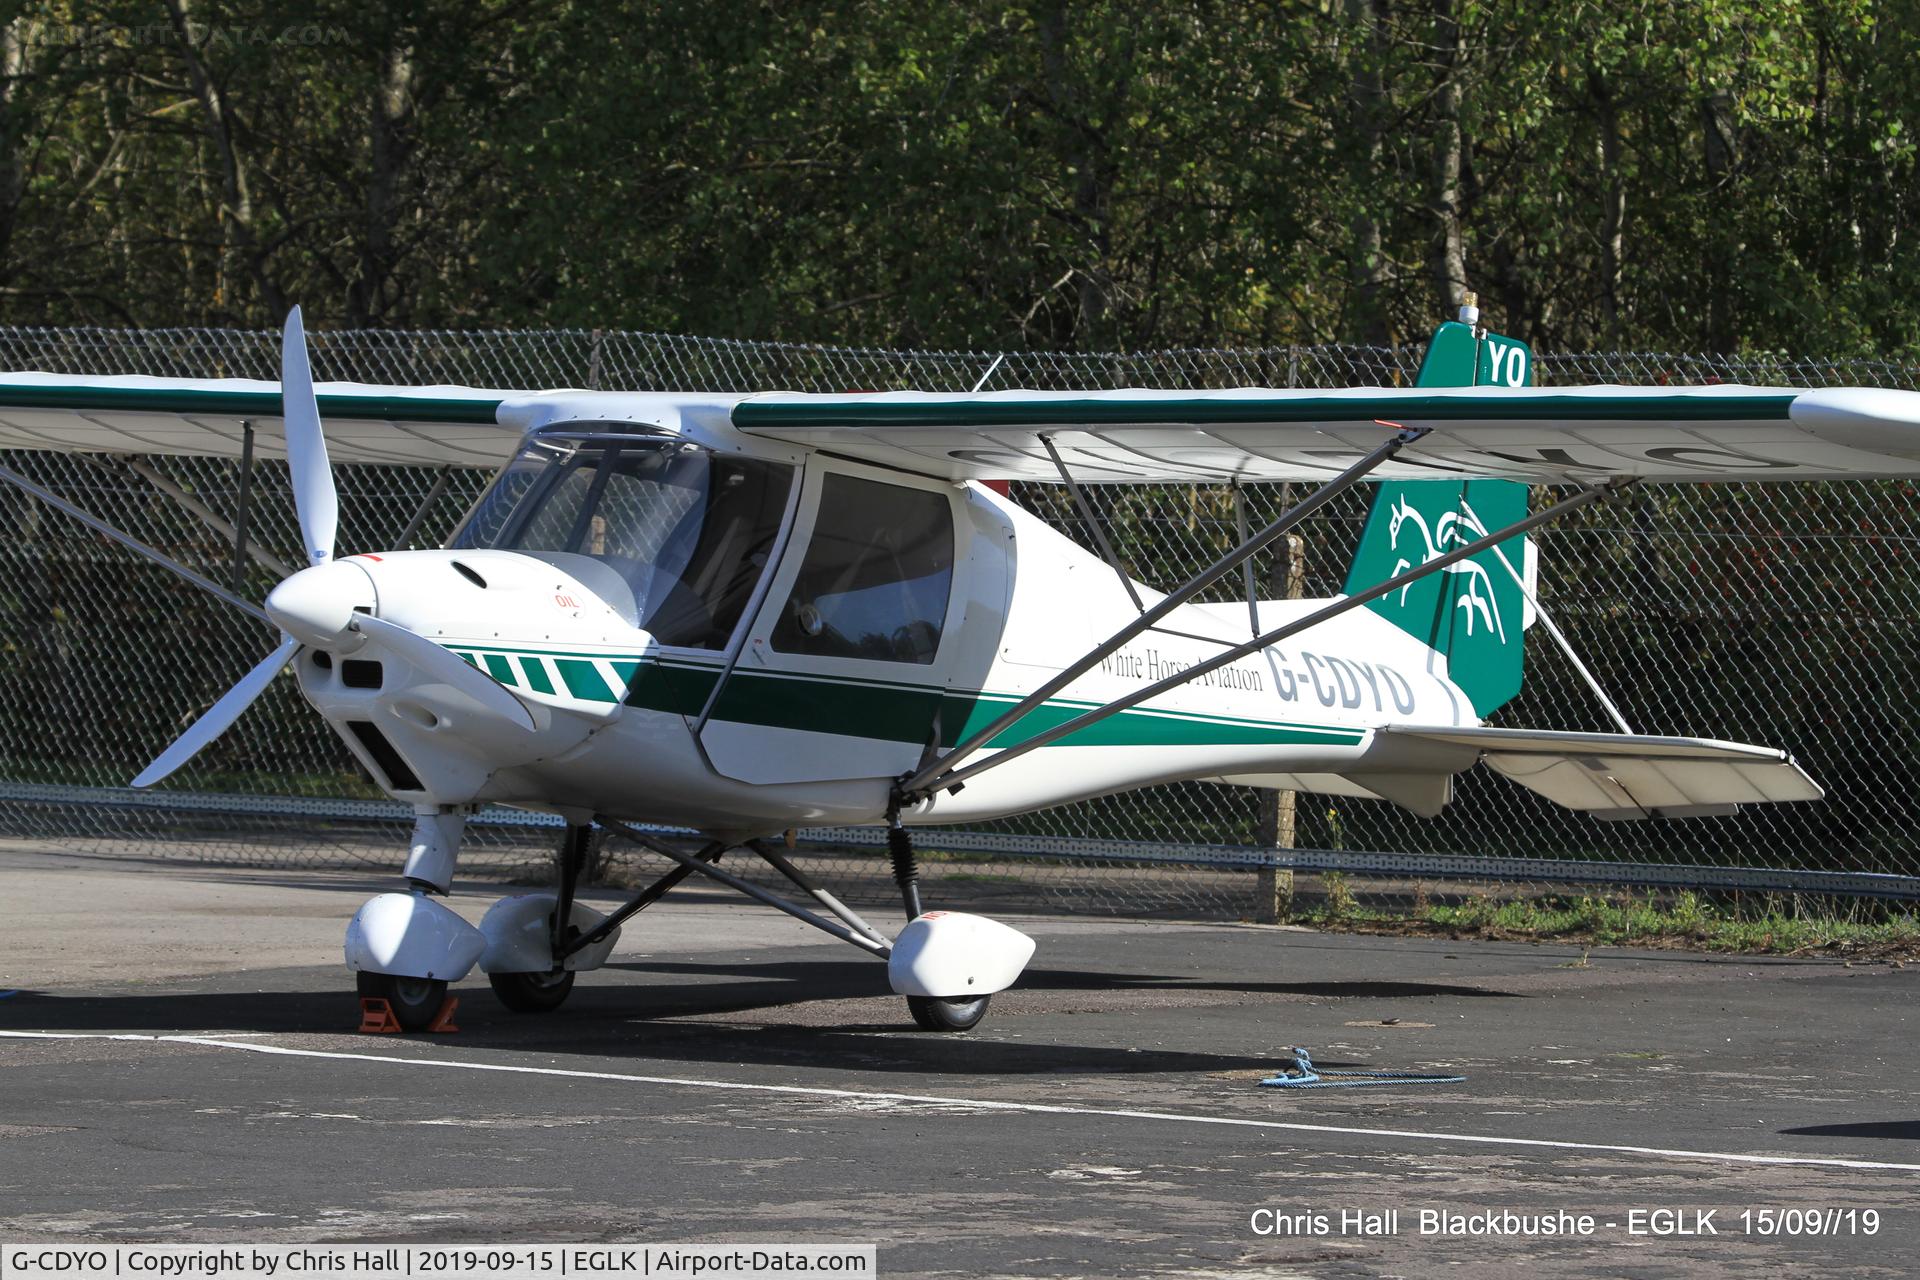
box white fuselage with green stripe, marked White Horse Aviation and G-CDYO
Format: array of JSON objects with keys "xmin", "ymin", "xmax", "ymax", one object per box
[{"xmin": 284, "ymin": 397, "xmax": 1478, "ymax": 837}]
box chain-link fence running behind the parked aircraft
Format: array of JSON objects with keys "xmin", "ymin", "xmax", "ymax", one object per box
[{"xmin": 0, "ymin": 328, "xmax": 1920, "ymax": 915}]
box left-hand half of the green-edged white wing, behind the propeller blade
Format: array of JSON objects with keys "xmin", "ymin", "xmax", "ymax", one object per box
[{"xmin": 0, "ymin": 372, "xmax": 520, "ymax": 468}]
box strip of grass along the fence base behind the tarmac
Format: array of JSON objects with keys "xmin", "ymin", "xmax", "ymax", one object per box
[{"xmin": 1296, "ymin": 885, "xmax": 1920, "ymax": 958}]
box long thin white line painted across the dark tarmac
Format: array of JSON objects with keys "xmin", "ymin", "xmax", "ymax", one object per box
[{"xmin": 0, "ymin": 1031, "xmax": 1920, "ymax": 1173}]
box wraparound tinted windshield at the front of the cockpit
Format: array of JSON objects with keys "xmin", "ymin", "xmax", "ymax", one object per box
[{"xmin": 449, "ymin": 439, "xmax": 793, "ymax": 649}]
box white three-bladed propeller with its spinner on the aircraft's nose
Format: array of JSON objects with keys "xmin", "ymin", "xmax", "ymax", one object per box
[{"xmin": 132, "ymin": 307, "xmax": 534, "ymax": 787}]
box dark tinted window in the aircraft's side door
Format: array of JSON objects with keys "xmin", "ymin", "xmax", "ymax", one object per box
[{"xmin": 772, "ymin": 474, "xmax": 954, "ymax": 666}]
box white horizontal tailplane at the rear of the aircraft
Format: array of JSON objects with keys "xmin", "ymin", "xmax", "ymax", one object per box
[{"xmin": 1380, "ymin": 725, "xmax": 1826, "ymax": 819}]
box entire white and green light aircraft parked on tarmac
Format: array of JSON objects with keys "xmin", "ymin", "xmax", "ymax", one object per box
[{"xmin": 0, "ymin": 311, "xmax": 1920, "ymax": 1031}]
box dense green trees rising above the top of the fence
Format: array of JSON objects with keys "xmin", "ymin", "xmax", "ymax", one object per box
[{"xmin": 0, "ymin": 0, "xmax": 1920, "ymax": 355}]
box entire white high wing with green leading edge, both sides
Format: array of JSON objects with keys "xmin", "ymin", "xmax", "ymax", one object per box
[{"xmin": 15, "ymin": 372, "xmax": 1920, "ymax": 484}]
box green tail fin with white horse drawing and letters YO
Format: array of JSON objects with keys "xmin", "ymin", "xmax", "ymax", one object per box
[{"xmin": 1346, "ymin": 320, "xmax": 1532, "ymax": 718}]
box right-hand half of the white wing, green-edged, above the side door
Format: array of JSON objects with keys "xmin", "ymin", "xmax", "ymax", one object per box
[{"xmin": 733, "ymin": 384, "xmax": 1920, "ymax": 484}]
